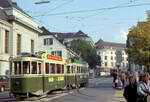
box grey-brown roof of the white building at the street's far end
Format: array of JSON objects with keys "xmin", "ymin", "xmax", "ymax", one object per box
[{"xmin": 95, "ymin": 39, "xmax": 126, "ymax": 49}]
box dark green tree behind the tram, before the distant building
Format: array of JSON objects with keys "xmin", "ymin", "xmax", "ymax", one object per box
[{"xmin": 71, "ymin": 39, "xmax": 100, "ymax": 68}]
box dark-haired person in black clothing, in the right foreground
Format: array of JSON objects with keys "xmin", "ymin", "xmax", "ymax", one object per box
[{"xmin": 123, "ymin": 76, "xmax": 137, "ymax": 102}]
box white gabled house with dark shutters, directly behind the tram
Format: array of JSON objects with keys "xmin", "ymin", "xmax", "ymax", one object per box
[{"xmin": 38, "ymin": 27, "xmax": 80, "ymax": 59}]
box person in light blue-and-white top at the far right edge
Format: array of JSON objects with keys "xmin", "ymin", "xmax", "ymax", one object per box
[{"xmin": 137, "ymin": 73, "xmax": 150, "ymax": 102}]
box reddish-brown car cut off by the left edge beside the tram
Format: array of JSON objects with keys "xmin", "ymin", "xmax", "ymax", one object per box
[{"xmin": 0, "ymin": 75, "xmax": 9, "ymax": 92}]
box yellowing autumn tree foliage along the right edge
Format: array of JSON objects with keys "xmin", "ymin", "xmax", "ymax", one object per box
[{"xmin": 126, "ymin": 14, "xmax": 150, "ymax": 66}]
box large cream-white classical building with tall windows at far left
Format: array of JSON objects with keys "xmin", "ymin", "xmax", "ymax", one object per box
[{"xmin": 0, "ymin": 0, "xmax": 41, "ymax": 75}]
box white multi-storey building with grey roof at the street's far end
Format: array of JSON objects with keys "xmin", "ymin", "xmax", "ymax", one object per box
[{"xmin": 95, "ymin": 39, "xmax": 128, "ymax": 71}]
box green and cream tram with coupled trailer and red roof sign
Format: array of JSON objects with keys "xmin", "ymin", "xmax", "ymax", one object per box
[{"xmin": 10, "ymin": 54, "xmax": 88, "ymax": 97}]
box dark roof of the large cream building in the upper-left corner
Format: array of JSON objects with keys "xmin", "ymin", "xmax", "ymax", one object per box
[{"xmin": 0, "ymin": 0, "xmax": 31, "ymax": 17}]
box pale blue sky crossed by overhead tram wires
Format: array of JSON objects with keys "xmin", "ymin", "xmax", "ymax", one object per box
[{"xmin": 13, "ymin": 0, "xmax": 150, "ymax": 43}]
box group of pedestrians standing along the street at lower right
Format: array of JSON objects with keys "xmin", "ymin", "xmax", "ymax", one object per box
[{"xmin": 113, "ymin": 72, "xmax": 150, "ymax": 102}]
